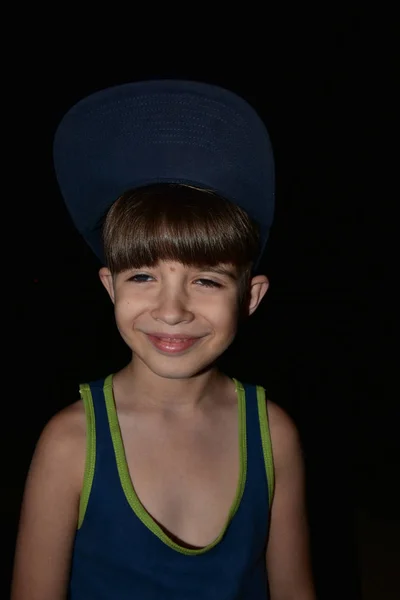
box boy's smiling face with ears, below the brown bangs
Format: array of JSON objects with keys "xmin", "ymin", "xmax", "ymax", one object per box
[{"xmin": 100, "ymin": 261, "xmax": 268, "ymax": 379}]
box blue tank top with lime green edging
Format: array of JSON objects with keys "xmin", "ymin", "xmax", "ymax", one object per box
[{"xmin": 69, "ymin": 376, "xmax": 273, "ymax": 600}]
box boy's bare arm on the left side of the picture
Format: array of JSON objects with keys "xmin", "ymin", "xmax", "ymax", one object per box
[{"xmin": 11, "ymin": 402, "xmax": 86, "ymax": 600}]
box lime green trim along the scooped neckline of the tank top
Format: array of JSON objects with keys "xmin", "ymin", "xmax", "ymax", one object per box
[{"xmin": 104, "ymin": 375, "xmax": 247, "ymax": 556}]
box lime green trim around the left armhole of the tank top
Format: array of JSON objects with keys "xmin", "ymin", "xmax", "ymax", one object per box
[{"xmin": 78, "ymin": 383, "xmax": 96, "ymax": 529}]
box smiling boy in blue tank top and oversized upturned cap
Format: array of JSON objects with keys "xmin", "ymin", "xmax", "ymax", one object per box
[{"xmin": 12, "ymin": 81, "xmax": 315, "ymax": 600}]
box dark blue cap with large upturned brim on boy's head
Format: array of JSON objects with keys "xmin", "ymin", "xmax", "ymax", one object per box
[{"xmin": 54, "ymin": 80, "xmax": 275, "ymax": 268}]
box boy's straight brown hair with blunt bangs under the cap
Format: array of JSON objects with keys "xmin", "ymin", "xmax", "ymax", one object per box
[{"xmin": 103, "ymin": 183, "xmax": 259, "ymax": 300}]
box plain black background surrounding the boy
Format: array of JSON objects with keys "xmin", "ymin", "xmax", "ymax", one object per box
[{"xmin": 6, "ymin": 5, "xmax": 399, "ymax": 600}]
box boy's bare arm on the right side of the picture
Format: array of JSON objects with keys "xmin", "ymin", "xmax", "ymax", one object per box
[{"xmin": 266, "ymin": 402, "xmax": 316, "ymax": 600}]
